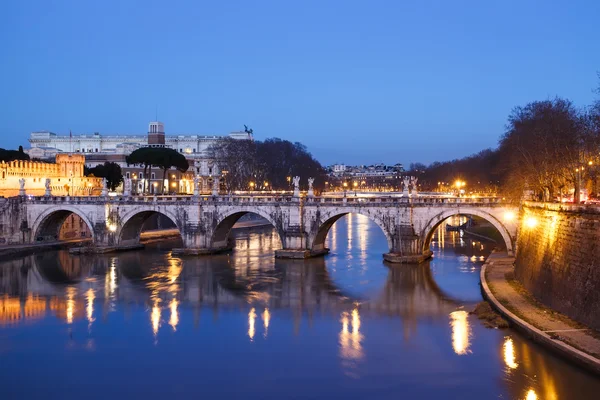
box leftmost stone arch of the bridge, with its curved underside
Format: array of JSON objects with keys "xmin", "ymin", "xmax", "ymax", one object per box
[{"xmin": 31, "ymin": 206, "xmax": 94, "ymax": 242}]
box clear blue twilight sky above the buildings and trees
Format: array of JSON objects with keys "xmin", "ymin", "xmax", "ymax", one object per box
[{"xmin": 0, "ymin": 0, "xmax": 600, "ymax": 164}]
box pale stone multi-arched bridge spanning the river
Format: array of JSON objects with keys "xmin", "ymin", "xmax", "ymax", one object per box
[{"xmin": 0, "ymin": 195, "xmax": 519, "ymax": 263}]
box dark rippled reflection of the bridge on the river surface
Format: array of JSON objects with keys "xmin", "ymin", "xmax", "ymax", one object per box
[{"xmin": 0, "ymin": 251, "xmax": 464, "ymax": 320}]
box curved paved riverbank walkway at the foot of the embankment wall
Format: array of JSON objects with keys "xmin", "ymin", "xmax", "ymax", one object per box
[{"xmin": 481, "ymin": 252, "xmax": 600, "ymax": 374}]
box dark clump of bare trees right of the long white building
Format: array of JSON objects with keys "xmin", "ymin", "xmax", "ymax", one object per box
[{"xmin": 209, "ymin": 138, "xmax": 326, "ymax": 191}]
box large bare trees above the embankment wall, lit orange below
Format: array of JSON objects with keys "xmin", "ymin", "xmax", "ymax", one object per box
[{"xmin": 410, "ymin": 76, "xmax": 600, "ymax": 201}]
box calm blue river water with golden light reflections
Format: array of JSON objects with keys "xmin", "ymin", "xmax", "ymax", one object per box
[{"xmin": 0, "ymin": 214, "xmax": 600, "ymax": 400}]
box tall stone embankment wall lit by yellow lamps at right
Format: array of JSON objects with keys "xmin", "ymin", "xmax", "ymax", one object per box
[{"xmin": 515, "ymin": 203, "xmax": 600, "ymax": 330}]
